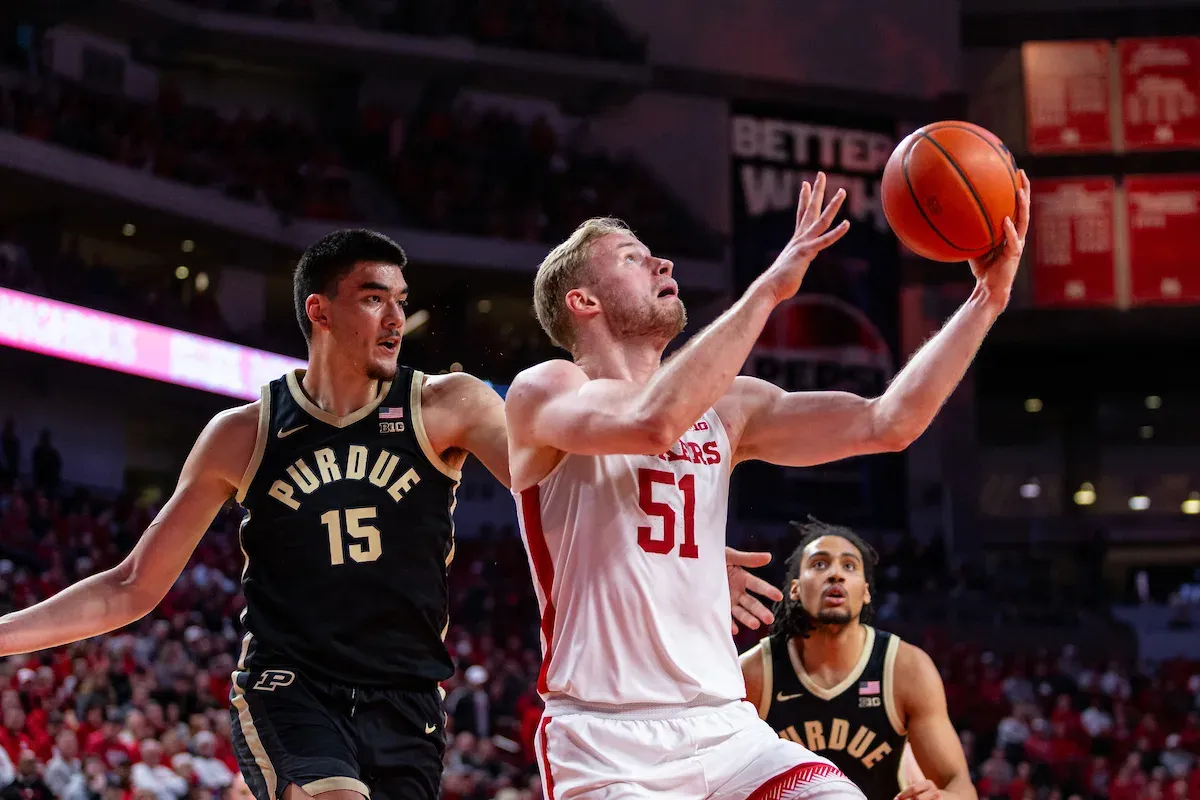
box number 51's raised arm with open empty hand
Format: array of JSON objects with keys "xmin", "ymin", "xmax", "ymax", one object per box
[{"xmin": 505, "ymin": 174, "xmax": 850, "ymax": 455}]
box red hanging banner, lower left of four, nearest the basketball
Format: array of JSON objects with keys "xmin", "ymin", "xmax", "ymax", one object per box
[{"xmin": 1031, "ymin": 178, "xmax": 1116, "ymax": 306}]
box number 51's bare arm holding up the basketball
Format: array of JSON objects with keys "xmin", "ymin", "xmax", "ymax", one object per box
[{"xmin": 716, "ymin": 172, "xmax": 1030, "ymax": 467}]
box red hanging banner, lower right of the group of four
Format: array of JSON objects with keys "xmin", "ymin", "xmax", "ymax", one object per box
[{"xmin": 1123, "ymin": 175, "xmax": 1200, "ymax": 305}]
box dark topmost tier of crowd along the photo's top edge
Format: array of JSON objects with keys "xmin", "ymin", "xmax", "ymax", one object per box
[{"xmin": 169, "ymin": 0, "xmax": 646, "ymax": 62}]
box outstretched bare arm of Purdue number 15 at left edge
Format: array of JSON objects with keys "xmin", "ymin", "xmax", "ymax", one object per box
[{"xmin": 0, "ymin": 404, "xmax": 258, "ymax": 656}]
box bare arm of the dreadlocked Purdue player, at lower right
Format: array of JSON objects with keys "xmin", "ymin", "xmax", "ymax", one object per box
[{"xmin": 894, "ymin": 642, "xmax": 978, "ymax": 800}]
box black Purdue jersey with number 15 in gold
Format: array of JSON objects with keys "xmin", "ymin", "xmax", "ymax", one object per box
[{"xmin": 238, "ymin": 367, "xmax": 461, "ymax": 687}]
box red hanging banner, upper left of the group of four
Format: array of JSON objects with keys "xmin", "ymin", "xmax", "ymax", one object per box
[{"xmin": 1021, "ymin": 41, "xmax": 1112, "ymax": 154}]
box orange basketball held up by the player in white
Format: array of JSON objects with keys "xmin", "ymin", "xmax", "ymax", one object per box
[{"xmin": 883, "ymin": 121, "xmax": 1019, "ymax": 261}]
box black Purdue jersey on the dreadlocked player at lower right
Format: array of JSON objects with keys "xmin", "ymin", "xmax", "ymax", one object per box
[{"xmin": 749, "ymin": 626, "xmax": 907, "ymax": 800}]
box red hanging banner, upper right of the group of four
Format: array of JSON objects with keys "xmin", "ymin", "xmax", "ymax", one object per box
[{"xmin": 1117, "ymin": 36, "xmax": 1200, "ymax": 150}]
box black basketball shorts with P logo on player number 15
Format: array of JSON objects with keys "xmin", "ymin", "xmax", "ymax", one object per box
[{"xmin": 229, "ymin": 668, "xmax": 445, "ymax": 800}]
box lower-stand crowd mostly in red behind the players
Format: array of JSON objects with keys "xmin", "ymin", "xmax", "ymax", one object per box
[{"xmin": 0, "ymin": 421, "xmax": 1200, "ymax": 800}]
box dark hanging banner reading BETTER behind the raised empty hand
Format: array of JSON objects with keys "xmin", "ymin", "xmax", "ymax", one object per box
[{"xmin": 730, "ymin": 103, "xmax": 902, "ymax": 524}]
